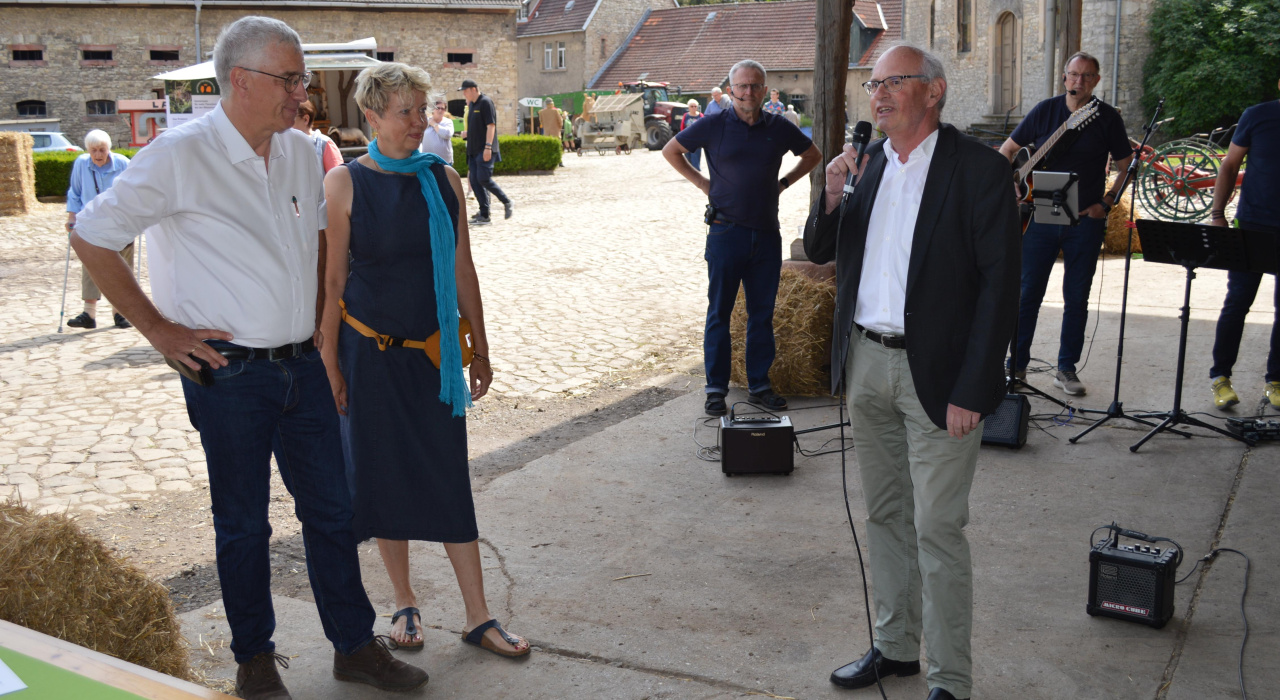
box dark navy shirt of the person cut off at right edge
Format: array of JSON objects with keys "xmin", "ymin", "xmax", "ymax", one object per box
[{"xmin": 1231, "ymin": 100, "xmax": 1280, "ymax": 227}]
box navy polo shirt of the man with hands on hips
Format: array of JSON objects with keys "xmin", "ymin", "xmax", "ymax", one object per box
[{"xmin": 676, "ymin": 109, "xmax": 813, "ymax": 232}]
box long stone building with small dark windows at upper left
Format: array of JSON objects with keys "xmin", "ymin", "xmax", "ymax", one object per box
[{"xmin": 0, "ymin": 0, "xmax": 520, "ymax": 145}]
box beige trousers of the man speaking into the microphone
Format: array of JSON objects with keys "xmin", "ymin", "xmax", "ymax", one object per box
[{"xmin": 845, "ymin": 333, "xmax": 983, "ymax": 697}]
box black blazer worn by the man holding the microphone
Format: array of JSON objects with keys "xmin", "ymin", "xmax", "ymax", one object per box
[{"xmin": 804, "ymin": 124, "xmax": 1021, "ymax": 429}]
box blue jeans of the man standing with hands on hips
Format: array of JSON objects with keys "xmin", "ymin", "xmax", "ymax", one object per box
[{"xmin": 703, "ymin": 224, "xmax": 782, "ymax": 394}]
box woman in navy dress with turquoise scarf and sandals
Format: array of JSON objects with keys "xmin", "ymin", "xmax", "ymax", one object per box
[{"xmin": 321, "ymin": 63, "xmax": 529, "ymax": 656}]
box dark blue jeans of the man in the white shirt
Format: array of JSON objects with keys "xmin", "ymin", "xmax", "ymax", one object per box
[{"xmin": 182, "ymin": 342, "xmax": 374, "ymax": 663}]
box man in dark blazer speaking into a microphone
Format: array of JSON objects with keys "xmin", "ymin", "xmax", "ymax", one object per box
[{"xmin": 804, "ymin": 46, "xmax": 1020, "ymax": 700}]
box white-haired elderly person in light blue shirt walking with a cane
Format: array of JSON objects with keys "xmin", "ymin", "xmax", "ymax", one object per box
[{"xmin": 63, "ymin": 129, "xmax": 133, "ymax": 329}]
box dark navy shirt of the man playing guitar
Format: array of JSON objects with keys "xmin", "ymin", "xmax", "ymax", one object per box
[{"xmin": 1009, "ymin": 95, "xmax": 1133, "ymax": 210}]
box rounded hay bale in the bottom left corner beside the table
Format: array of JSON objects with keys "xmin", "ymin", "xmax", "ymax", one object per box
[{"xmin": 0, "ymin": 503, "xmax": 192, "ymax": 680}]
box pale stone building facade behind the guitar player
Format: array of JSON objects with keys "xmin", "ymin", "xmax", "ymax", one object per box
[{"xmin": 902, "ymin": 0, "xmax": 1153, "ymax": 132}]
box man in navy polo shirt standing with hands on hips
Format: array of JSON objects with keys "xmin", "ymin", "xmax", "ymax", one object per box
[{"xmin": 662, "ymin": 60, "xmax": 822, "ymax": 416}]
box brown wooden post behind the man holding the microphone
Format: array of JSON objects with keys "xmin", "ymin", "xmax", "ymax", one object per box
[{"xmin": 809, "ymin": 0, "xmax": 854, "ymax": 202}]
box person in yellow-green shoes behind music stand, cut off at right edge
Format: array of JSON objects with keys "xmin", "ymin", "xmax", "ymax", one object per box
[{"xmin": 1208, "ymin": 82, "xmax": 1280, "ymax": 408}]
